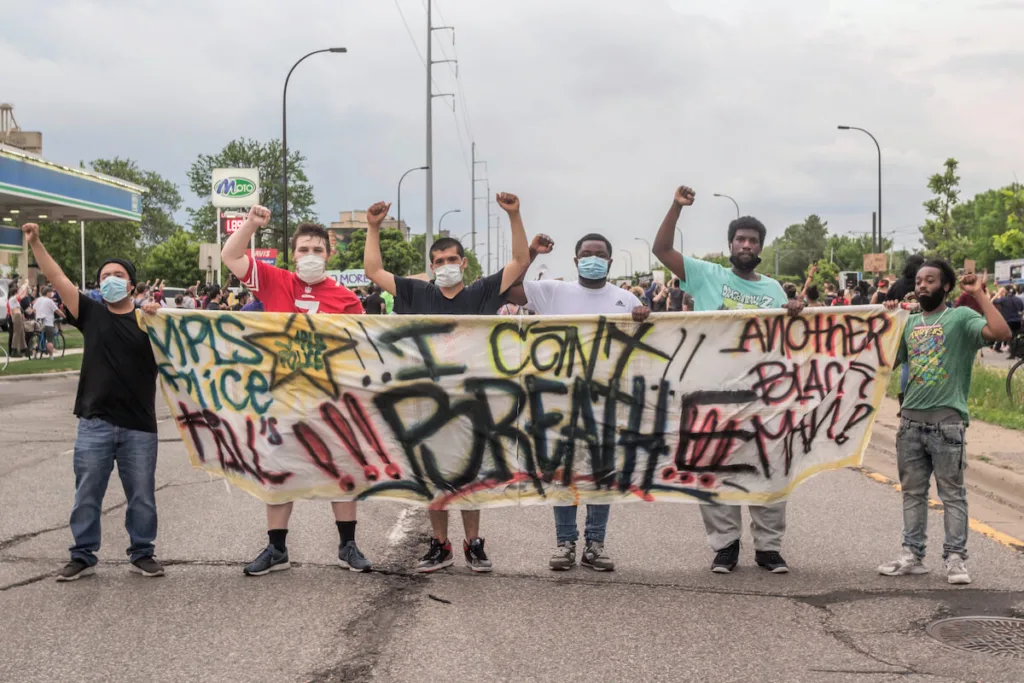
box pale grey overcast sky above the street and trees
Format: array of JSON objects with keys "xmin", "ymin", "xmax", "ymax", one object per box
[{"xmin": 0, "ymin": 0, "xmax": 1024, "ymax": 275}]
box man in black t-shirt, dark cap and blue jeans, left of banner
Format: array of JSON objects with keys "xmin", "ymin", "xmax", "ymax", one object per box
[{"xmin": 22, "ymin": 223, "xmax": 164, "ymax": 581}]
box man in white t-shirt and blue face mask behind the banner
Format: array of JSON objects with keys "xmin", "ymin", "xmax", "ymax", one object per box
[{"xmin": 509, "ymin": 233, "xmax": 650, "ymax": 571}]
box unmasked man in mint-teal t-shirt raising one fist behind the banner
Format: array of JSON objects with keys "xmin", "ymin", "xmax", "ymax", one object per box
[{"xmin": 653, "ymin": 186, "xmax": 804, "ymax": 573}]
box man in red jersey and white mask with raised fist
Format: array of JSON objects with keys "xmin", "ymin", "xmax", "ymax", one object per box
[{"xmin": 220, "ymin": 206, "xmax": 371, "ymax": 577}]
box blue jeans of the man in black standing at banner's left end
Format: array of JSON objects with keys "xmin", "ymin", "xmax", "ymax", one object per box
[{"xmin": 71, "ymin": 419, "xmax": 157, "ymax": 566}]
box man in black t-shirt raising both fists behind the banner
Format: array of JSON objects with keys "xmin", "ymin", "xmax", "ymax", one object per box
[{"xmin": 362, "ymin": 193, "xmax": 530, "ymax": 572}]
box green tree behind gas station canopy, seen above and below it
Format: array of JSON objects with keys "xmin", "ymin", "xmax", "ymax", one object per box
[{"xmin": 30, "ymin": 158, "xmax": 181, "ymax": 286}]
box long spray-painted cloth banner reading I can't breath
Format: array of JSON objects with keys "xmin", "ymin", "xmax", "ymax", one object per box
[{"xmin": 139, "ymin": 307, "xmax": 906, "ymax": 508}]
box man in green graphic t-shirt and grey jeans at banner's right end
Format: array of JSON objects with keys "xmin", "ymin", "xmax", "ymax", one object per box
[{"xmin": 879, "ymin": 260, "xmax": 1010, "ymax": 584}]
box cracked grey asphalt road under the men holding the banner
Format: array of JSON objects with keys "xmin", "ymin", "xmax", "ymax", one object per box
[{"xmin": 0, "ymin": 378, "xmax": 1024, "ymax": 683}]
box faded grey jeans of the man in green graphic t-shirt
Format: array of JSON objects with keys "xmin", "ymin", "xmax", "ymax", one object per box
[{"xmin": 896, "ymin": 418, "xmax": 968, "ymax": 559}]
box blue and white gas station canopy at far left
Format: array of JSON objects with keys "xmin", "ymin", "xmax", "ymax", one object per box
[{"xmin": 0, "ymin": 144, "xmax": 145, "ymax": 252}]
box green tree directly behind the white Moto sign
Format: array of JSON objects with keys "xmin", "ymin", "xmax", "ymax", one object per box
[{"xmin": 188, "ymin": 137, "xmax": 315, "ymax": 251}]
